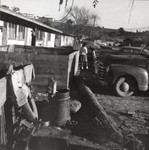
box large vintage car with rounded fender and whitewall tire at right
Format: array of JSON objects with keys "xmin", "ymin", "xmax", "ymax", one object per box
[{"xmin": 96, "ymin": 46, "xmax": 149, "ymax": 97}]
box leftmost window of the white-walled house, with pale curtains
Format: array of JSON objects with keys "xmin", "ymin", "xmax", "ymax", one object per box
[{"xmin": 8, "ymin": 23, "xmax": 17, "ymax": 39}]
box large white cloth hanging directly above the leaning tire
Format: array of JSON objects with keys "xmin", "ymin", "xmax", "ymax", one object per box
[{"xmin": 11, "ymin": 69, "xmax": 30, "ymax": 107}]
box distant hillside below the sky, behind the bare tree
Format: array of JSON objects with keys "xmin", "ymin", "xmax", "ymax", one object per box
[{"xmin": 37, "ymin": 17, "xmax": 149, "ymax": 45}]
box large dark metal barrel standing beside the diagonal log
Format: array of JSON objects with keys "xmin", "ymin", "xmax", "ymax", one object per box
[{"xmin": 49, "ymin": 89, "xmax": 70, "ymax": 126}]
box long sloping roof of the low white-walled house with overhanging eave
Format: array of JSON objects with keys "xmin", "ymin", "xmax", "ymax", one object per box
[{"xmin": 0, "ymin": 7, "xmax": 63, "ymax": 34}]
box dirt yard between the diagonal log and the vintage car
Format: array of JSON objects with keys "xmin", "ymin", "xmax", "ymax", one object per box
[{"xmin": 81, "ymin": 70, "xmax": 149, "ymax": 150}]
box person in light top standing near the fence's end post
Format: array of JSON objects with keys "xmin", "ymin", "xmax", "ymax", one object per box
[{"xmin": 80, "ymin": 43, "xmax": 88, "ymax": 69}]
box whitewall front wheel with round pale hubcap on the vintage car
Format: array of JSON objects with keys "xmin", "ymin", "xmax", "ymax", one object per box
[{"xmin": 115, "ymin": 77, "xmax": 134, "ymax": 97}]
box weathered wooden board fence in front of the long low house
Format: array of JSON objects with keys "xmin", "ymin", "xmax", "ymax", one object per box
[{"xmin": 0, "ymin": 45, "xmax": 79, "ymax": 91}]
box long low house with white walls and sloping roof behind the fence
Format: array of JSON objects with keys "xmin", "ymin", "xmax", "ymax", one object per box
[{"xmin": 0, "ymin": 7, "xmax": 73, "ymax": 47}]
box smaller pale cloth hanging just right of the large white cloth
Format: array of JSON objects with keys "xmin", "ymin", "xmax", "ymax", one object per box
[{"xmin": 24, "ymin": 64, "xmax": 35, "ymax": 84}]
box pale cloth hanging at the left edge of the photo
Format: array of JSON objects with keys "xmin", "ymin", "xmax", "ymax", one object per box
[{"xmin": 0, "ymin": 77, "xmax": 7, "ymax": 108}]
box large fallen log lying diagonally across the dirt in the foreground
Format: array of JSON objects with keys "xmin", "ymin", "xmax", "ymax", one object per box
[{"xmin": 72, "ymin": 76, "xmax": 123, "ymax": 143}]
